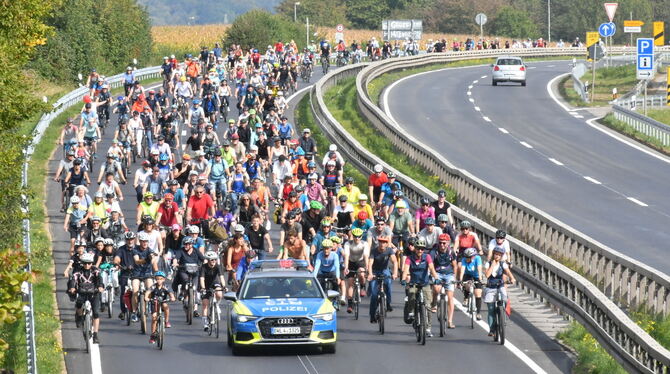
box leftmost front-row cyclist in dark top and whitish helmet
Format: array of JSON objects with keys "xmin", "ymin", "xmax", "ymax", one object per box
[{"xmin": 68, "ymin": 253, "xmax": 104, "ymax": 344}]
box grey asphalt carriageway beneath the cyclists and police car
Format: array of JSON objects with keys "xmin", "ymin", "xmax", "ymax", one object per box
[{"xmin": 45, "ymin": 65, "xmax": 572, "ymax": 374}]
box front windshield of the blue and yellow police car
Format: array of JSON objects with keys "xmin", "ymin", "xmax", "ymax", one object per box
[{"xmin": 240, "ymin": 277, "xmax": 323, "ymax": 299}]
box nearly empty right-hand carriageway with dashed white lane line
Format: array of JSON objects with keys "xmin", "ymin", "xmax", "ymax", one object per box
[{"xmin": 382, "ymin": 61, "xmax": 670, "ymax": 269}]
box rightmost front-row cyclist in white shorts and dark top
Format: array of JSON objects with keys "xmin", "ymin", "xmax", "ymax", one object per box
[{"xmin": 484, "ymin": 247, "xmax": 516, "ymax": 336}]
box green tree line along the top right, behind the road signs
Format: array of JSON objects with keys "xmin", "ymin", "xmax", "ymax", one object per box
[{"xmin": 276, "ymin": 0, "xmax": 670, "ymax": 43}]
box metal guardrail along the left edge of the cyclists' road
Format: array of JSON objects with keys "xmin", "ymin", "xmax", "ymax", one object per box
[{"xmin": 21, "ymin": 66, "xmax": 161, "ymax": 374}]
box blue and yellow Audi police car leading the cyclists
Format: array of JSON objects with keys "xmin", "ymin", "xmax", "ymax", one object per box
[{"xmin": 224, "ymin": 260, "xmax": 339, "ymax": 355}]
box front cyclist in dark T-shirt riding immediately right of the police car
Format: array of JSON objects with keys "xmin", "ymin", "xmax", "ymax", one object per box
[{"xmin": 368, "ymin": 237, "xmax": 398, "ymax": 323}]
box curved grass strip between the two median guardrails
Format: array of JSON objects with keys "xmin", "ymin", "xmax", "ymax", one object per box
[{"xmin": 324, "ymin": 77, "xmax": 456, "ymax": 203}]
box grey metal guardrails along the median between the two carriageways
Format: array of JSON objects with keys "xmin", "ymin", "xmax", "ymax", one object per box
[{"xmin": 310, "ymin": 55, "xmax": 670, "ymax": 373}]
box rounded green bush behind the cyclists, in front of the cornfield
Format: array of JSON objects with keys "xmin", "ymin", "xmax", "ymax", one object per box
[{"xmin": 224, "ymin": 9, "xmax": 305, "ymax": 51}]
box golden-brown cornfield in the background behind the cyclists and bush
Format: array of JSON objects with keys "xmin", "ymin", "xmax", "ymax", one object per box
[{"xmin": 151, "ymin": 24, "xmax": 536, "ymax": 51}]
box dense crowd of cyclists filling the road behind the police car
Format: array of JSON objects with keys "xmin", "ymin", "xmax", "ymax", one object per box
[{"xmin": 54, "ymin": 41, "xmax": 514, "ymax": 350}]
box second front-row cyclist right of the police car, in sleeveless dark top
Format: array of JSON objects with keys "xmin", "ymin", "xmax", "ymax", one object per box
[{"xmin": 402, "ymin": 239, "xmax": 438, "ymax": 337}]
